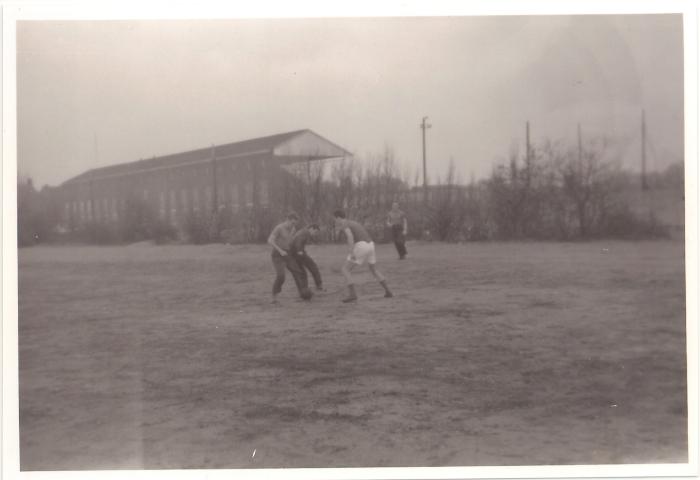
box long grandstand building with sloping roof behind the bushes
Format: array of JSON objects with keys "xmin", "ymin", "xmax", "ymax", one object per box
[{"xmin": 60, "ymin": 129, "xmax": 352, "ymax": 228}]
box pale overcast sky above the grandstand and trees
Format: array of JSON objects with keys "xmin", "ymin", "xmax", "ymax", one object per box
[{"xmin": 17, "ymin": 15, "xmax": 683, "ymax": 186}]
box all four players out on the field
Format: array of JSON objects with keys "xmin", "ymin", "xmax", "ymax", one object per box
[{"xmin": 267, "ymin": 203, "xmax": 408, "ymax": 303}]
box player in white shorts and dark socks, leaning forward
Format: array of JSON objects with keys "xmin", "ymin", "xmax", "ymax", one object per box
[{"xmin": 333, "ymin": 210, "xmax": 394, "ymax": 303}]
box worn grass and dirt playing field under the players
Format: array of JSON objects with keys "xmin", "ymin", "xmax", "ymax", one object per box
[{"xmin": 19, "ymin": 241, "xmax": 687, "ymax": 470}]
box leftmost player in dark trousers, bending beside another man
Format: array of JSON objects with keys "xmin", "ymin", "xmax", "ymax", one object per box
[{"xmin": 267, "ymin": 213, "xmax": 312, "ymax": 303}]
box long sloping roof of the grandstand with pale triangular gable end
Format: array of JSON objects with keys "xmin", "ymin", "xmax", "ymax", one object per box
[{"xmin": 63, "ymin": 129, "xmax": 352, "ymax": 185}]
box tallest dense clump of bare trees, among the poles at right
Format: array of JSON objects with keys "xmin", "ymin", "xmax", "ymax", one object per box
[{"xmin": 481, "ymin": 139, "xmax": 668, "ymax": 239}]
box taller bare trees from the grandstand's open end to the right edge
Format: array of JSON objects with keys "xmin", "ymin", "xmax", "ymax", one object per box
[{"xmin": 262, "ymin": 138, "xmax": 683, "ymax": 241}]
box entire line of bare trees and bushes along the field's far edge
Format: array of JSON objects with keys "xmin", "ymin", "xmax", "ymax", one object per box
[{"xmin": 18, "ymin": 139, "xmax": 683, "ymax": 245}]
